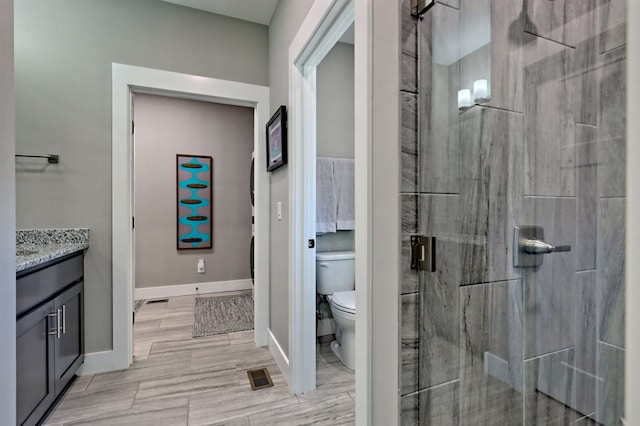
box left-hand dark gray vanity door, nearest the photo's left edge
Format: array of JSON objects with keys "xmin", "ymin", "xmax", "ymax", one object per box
[{"xmin": 16, "ymin": 302, "xmax": 56, "ymax": 425}]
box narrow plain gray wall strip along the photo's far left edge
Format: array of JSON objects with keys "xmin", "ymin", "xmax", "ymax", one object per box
[{"xmin": 0, "ymin": 0, "xmax": 16, "ymax": 424}]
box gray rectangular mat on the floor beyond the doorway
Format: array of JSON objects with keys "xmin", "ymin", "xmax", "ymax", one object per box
[{"xmin": 193, "ymin": 294, "xmax": 253, "ymax": 337}]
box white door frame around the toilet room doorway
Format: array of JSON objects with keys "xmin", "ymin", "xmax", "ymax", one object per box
[{"xmin": 289, "ymin": 0, "xmax": 371, "ymax": 424}]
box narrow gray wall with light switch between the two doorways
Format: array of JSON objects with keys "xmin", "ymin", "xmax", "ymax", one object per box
[{"xmin": 269, "ymin": 0, "xmax": 313, "ymax": 354}]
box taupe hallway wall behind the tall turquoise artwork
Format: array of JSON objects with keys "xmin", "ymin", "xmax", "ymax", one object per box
[{"xmin": 134, "ymin": 94, "xmax": 253, "ymax": 288}]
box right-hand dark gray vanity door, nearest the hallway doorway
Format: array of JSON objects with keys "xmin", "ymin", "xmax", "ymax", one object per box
[{"xmin": 54, "ymin": 282, "xmax": 84, "ymax": 394}]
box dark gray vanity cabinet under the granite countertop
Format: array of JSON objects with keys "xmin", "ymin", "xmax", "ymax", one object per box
[{"xmin": 16, "ymin": 254, "xmax": 84, "ymax": 425}]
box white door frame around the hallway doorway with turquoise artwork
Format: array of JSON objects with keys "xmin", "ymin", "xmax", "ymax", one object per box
[{"xmin": 107, "ymin": 63, "xmax": 269, "ymax": 374}]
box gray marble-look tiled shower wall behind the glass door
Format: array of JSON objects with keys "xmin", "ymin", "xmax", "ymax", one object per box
[{"xmin": 400, "ymin": 0, "xmax": 626, "ymax": 425}]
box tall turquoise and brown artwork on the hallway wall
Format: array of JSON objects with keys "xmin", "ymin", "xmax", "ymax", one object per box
[{"xmin": 176, "ymin": 154, "xmax": 213, "ymax": 250}]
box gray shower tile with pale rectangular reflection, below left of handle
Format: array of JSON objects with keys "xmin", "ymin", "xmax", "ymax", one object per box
[{"xmin": 460, "ymin": 280, "xmax": 523, "ymax": 425}]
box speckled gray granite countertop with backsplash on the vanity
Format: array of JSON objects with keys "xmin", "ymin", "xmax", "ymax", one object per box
[{"xmin": 16, "ymin": 228, "xmax": 89, "ymax": 272}]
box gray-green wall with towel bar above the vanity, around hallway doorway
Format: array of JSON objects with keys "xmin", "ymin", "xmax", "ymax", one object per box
[{"xmin": 15, "ymin": 0, "xmax": 268, "ymax": 352}]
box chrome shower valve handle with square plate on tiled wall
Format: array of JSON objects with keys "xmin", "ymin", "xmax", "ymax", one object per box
[{"xmin": 513, "ymin": 225, "xmax": 571, "ymax": 268}]
